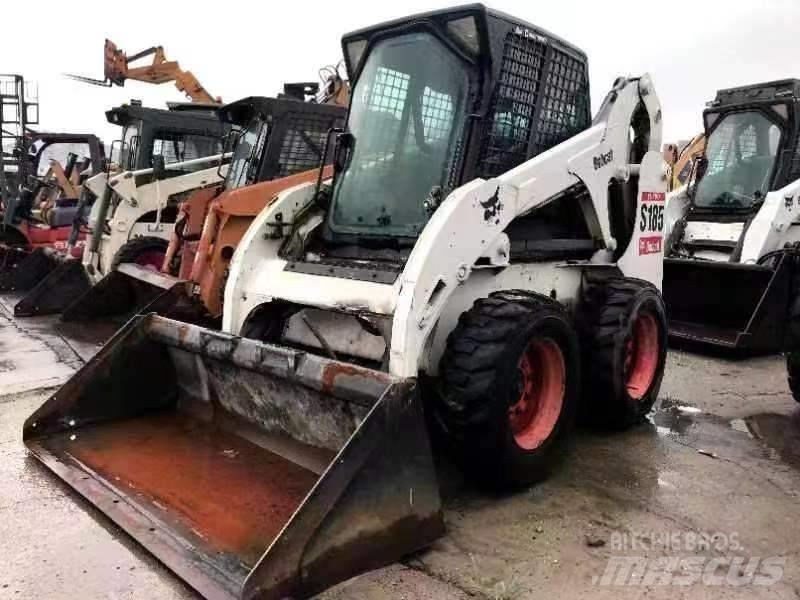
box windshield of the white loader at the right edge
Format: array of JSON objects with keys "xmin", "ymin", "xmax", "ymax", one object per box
[{"xmin": 694, "ymin": 111, "xmax": 781, "ymax": 209}]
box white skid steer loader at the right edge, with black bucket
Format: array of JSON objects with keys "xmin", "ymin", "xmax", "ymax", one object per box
[{"xmin": 664, "ymin": 80, "xmax": 800, "ymax": 352}]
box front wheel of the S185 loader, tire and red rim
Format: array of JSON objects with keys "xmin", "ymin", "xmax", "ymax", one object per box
[{"xmin": 434, "ymin": 291, "xmax": 580, "ymax": 488}]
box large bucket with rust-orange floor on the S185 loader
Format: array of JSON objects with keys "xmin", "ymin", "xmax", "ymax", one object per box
[{"xmin": 23, "ymin": 314, "xmax": 443, "ymax": 600}]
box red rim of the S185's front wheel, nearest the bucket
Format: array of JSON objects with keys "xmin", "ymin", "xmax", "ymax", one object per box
[{"xmin": 508, "ymin": 338, "xmax": 567, "ymax": 450}]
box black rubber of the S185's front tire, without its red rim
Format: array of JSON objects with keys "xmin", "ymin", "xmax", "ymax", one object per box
[{"xmin": 433, "ymin": 291, "xmax": 580, "ymax": 489}]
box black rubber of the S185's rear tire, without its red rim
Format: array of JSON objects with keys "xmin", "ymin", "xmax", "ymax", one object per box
[{"xmin": 579, "ymin": 278, "xmax": 667, "ymax": 430}]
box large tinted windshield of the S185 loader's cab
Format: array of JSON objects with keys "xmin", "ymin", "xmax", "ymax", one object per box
[{"xmin": 329, "ymin": 33, "xmax": 469, "ymax": 237}]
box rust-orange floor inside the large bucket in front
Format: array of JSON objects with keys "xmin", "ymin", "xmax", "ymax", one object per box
[{"xmin": 62, "ymin": 414, "xmax": 317, "ymax": 567}]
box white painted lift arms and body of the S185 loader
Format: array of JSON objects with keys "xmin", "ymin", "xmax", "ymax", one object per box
[{"xmin": 223, "ymin": 76, "xmax": 667, "ymax": 377}]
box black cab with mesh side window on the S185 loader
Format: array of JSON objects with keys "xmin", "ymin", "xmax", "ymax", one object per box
[{"xmin": 312, "ymin": 4, "xmax": 590, "ymax": 261}]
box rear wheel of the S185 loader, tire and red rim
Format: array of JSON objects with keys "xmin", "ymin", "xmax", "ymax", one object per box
[{"xmin": 581, "ymin": 278, "xmax": 667, "ymax": 429}]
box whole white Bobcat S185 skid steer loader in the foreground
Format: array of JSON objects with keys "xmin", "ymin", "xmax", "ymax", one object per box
[{"xmin": 24, "ymin": 5, "xmax": 667, "ymax": 600}]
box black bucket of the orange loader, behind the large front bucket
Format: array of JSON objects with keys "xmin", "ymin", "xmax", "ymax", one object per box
[{"xmin": 60, "ymin": 263, "xmax": 194, "ymax": 342}]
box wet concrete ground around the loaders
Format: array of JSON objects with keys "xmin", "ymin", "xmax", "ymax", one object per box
[{"xmin": 0, "ymin": 303, "xmax": 800, "ymax": 600}]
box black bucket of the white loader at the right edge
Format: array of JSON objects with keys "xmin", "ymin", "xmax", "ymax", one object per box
[{"xmin": 663, "ymin": 257, "xmax": 790, "ymax": 352}]
